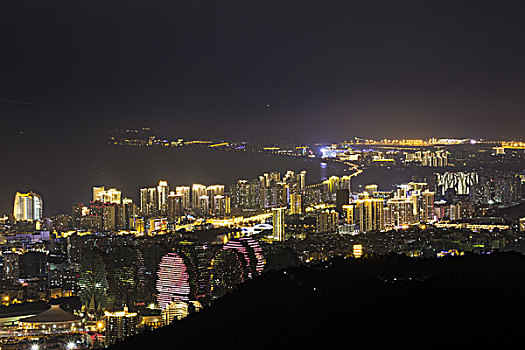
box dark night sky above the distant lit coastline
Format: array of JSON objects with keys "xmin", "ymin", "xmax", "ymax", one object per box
[{"xmin": 0, "ymin": 0, "xmax": 525, "ymax": 140}]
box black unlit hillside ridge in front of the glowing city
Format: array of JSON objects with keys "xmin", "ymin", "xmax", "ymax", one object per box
[{"xmin": 113, "ymin": 253, "xmax": 525, "ymax": 350}]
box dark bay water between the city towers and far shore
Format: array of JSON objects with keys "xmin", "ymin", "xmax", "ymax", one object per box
[{"xmin": 0, "ymin": 134, "xmax": 350, "ymax": 216}]
